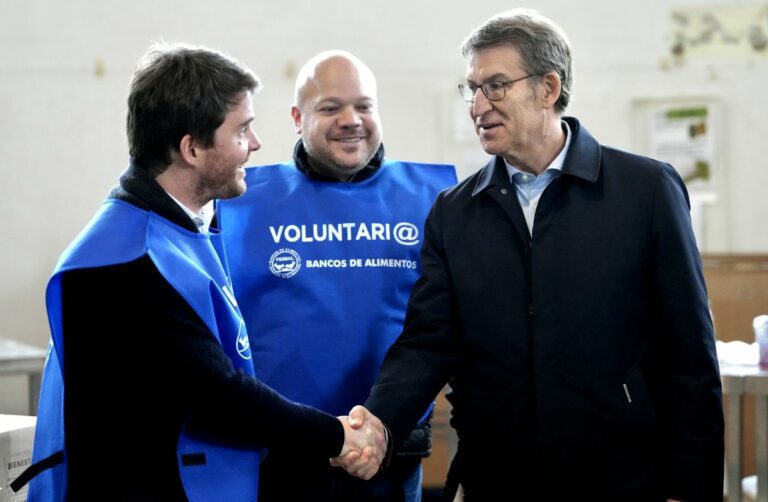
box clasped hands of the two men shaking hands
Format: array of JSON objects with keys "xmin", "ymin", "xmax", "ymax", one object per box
[{"xmin": 331, "ymin": 406, "xmax": 387, "ymax": 479}]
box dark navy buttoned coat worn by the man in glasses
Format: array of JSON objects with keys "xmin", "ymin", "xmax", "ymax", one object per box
[{"xmin": 366, "ymin": 118, "xmax": 723, "ymax": 500}]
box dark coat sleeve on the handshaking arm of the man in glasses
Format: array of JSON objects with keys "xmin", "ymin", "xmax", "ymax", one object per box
[{"xmin": 365, "ymin": 194, "xmax": 460, "ymax": 446}]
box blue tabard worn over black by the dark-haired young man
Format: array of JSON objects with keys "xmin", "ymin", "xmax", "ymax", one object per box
[{"xmin": 28, "ymin": 199, "xmax": 263, "ymax": 502}]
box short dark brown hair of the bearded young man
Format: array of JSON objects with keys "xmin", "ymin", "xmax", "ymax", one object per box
[{"xmin": 127, "ymin": 43, "xmax": 261, "ymax": 176}]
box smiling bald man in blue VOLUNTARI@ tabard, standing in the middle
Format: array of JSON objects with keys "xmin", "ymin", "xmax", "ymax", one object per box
[{"xmin": 217, "ymin": 51, "xmax": 456, "ymax": 502}]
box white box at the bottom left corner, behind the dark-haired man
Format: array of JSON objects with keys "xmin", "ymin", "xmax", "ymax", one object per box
[{"xmin": 0, "ymin": 415, "xmax": 37, "ymax": 502}]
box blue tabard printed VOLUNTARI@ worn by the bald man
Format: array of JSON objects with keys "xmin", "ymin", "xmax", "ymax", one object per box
[{"xmin": 217, "ymin": 161, "xmax": 456, "ymax": 415}]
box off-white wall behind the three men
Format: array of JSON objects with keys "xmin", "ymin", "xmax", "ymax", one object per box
[{"xmin": 0, "ymin": 0, "xmax": 768, "ymax": 409}]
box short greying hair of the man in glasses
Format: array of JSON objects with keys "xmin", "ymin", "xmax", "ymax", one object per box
[{"xmin": 461, "ymin": 9, "xmax": 573, "ymax": 113}]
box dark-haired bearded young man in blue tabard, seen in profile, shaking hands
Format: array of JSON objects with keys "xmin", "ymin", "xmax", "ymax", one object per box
[{"xmin": 16, "ymin": 46, "xmax": 386, "ymax": 501}]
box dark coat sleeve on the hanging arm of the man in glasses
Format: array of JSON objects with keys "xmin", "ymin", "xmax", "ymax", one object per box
[{"xmin": 651, "ymin": 165, "xmax": 724, "ymax": 500}]
